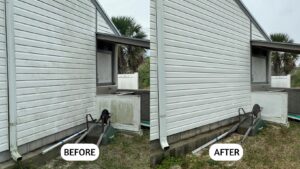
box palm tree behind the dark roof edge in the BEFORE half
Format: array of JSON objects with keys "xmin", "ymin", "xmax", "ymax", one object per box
[{"xmin": 112, "ymin": 16, "xmax": 147, "ymax": 73}]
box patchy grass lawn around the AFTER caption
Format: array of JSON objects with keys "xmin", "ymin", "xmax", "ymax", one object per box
[{"xmin": 157, "ymin": 121, "xmax": 300, "ymax": 169}]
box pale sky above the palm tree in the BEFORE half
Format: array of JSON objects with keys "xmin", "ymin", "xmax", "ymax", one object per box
[{"xmin": 98, "ymin": 0, "xmax": 150, "ymax": 39}]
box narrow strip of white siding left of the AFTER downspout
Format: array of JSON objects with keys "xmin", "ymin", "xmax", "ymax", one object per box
[{"xmin": 150, "ymin": 0, "xmax": 158, "ymax": 140}]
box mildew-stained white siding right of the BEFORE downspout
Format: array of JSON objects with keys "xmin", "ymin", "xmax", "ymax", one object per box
[{"xmin": 14, "ymin": 0, "xmax": 98, "ymax": 145}]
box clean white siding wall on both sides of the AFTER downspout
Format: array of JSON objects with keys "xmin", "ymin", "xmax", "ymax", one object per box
[{"xmin": 150, "ymin": 0, "xmax": 251, "ymax": 140}]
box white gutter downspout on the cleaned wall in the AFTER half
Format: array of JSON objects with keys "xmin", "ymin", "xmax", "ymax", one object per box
[{"xmin": 156, "ymin": 0, "xmax": 169, "ymax": 150}]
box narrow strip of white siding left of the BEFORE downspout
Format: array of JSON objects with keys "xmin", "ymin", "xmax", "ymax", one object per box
[{"xmin": 0, "ymin": 0, "xmax": 8, "ymax": 152}]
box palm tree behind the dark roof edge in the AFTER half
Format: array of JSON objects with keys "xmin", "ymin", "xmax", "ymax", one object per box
[{"xmin": 271, "ymin": 33, "xmax": 298, "ymax": 75}]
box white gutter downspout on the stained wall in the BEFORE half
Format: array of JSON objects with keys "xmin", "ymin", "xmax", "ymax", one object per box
[{"xmin": 5, "ymin": 0, "xmax": 22, "ymax": 161}]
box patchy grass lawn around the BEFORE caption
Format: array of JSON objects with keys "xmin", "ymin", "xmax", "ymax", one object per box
[{"xmin": 16, "ymin": 130, "xmax": 150, "ymax": 169}]
